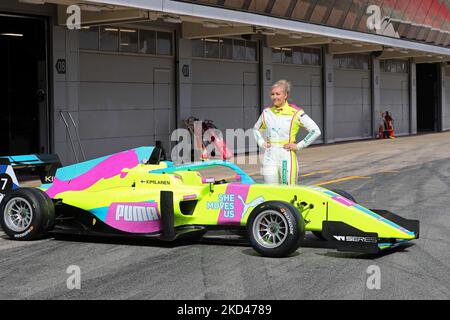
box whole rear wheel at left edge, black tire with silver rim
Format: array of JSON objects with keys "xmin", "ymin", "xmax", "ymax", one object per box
[{"xmin": 0, "ymin": 188, "xmax": 55, "ymax": 240}]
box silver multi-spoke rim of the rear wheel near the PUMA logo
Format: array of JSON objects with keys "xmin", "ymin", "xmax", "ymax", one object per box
[{"xmin": 4, "ymin": 198, "xmax": 33, "ymax": 232}]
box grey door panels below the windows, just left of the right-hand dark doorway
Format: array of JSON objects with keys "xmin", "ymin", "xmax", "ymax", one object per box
[{"xmin": 382, "ymin": 72, "xmax": 410, "ymax": 135}]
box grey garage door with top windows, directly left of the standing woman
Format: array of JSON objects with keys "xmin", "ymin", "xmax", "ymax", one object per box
[{"xmin": 191, "ymin": 39, "xmax": 259, "ymax": 153}]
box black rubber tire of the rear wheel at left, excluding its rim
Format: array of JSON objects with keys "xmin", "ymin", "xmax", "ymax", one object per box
[{"xmin": 0, "ymin": 188, "xmax": 54, "ymax": 240}]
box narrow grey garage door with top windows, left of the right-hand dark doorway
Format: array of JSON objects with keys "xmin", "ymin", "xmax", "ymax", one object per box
[{"xmin": 376, "ymin": 60, "xmax": 409, "ymax": 135}]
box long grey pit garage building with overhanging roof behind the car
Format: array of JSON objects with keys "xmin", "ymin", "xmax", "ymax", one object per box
[{"xmin": 0, "ymin": 0, "xmax": 450, "ymax": 164}]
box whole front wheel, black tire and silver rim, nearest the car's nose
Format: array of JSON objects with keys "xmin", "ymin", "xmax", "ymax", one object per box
[{"xmin": 247, "ymin": 201, "xmax": 305, "ymax": 258}]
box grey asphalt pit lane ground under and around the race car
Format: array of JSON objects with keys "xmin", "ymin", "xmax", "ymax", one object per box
[{"xmin": 0, "ymin": 132, "xmax": 450, "ymax": 300}]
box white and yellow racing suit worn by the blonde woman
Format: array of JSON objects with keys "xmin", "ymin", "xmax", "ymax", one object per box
[{"xmin": 253, "ymin": 102, "xmax": 321, "ymax": 185}]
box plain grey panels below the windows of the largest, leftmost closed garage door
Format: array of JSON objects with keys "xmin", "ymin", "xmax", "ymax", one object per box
[{"xmin": 79, "ymin": 52, "xmax": 175, "ymax": 156}]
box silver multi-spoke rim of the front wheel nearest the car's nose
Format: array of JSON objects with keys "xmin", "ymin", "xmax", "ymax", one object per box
[{"xmin": 253, "ymin": 210, "xmax": 288, "ymax": 249}]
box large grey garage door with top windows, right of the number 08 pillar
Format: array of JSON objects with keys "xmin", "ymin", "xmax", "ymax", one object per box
[{"xmin": 78, "ymin": 27, "xmax": 175, "ymax": 158}]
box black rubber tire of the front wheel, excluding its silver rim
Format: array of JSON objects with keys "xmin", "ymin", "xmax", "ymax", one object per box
[{"xmin": 247, "ymin": 201, "xmax": 305, "ymax": 258}]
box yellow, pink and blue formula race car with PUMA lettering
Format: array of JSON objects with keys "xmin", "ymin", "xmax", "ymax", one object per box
[{"xmin": 0, "ymin": 147, "xmax": 419, "ymax": 257}]
